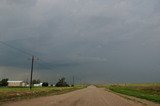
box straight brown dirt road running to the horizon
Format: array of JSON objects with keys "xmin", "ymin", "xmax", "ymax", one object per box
[{"xmin": 3, "ymin": 86, "xmax": 160, "ymax": 106}]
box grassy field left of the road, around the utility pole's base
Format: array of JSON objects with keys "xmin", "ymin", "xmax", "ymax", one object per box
[{"xmin": 0, "ymin": 86, "xmax": 85, "ymax": 104}]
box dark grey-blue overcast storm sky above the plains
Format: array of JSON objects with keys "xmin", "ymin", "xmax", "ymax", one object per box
[{"xmin": 0, "ymin": 0, "xmax": 160, "ymax": 83}]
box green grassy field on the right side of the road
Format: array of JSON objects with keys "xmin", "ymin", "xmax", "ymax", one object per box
[{"xmin": 109, "ymin": 83, "xmax": 160, "ymax": 103}]
